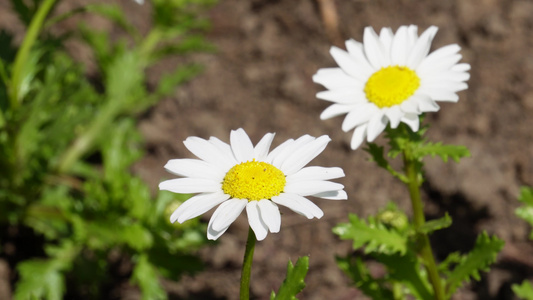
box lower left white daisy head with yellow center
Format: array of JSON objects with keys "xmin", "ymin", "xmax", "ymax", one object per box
[{"xmin": 159, "ymin": 129, "xmax": 347, "ymax": 240}]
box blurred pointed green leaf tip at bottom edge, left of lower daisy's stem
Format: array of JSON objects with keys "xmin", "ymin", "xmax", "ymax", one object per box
[{"xmin": 131, "ymin": 254, "xmax": 167, "ymax": 300}]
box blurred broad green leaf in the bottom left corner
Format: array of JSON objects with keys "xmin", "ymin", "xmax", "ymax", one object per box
[{"xmin": 14, "ymin": 259, "xmax": 65, "ymax": 300}]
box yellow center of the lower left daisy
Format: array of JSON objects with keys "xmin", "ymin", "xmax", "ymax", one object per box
[{"xmin": 222, "ymin": 160, "xmax": 287, "ymax": 201}]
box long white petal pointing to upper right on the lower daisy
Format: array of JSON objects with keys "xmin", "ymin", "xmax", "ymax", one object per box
[{"xmin": 280, "ymin": 135, "xmax": 331, "ymax": 176}]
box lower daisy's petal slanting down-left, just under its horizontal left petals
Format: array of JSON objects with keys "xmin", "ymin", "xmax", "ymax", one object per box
[{"xmin": 170, "ymin": 192, "xmax": 230, "ymax": 223}]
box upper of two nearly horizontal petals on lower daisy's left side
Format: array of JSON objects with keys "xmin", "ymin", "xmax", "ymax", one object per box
[{"xmin": 165, "ymin": 158, "xmax": 225, "ymax": 181}]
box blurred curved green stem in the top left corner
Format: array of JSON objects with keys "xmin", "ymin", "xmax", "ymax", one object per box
[{"xmin": 9, "ymin": 0, "xmax": 55, "ymax": 108}]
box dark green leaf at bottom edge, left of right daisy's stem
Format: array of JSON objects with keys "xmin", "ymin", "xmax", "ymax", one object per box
[{"xmin": 336, "ymin": 256, "xmax": 394, "ymax": 300}]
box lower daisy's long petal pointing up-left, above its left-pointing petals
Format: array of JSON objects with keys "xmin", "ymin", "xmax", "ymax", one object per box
[{"xmin": 183, "ymin": 136, "xmax": 234, "ymax": 171}]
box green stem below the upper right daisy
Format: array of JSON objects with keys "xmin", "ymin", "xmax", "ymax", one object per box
[{"xmin": 403, "ymin": 149, "xmax": 446, "ymax": 300}]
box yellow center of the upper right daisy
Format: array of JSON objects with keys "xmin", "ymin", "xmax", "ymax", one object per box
[{"xmin": 365, "ymin": 66, "xmax": 420, "ymax": 108}]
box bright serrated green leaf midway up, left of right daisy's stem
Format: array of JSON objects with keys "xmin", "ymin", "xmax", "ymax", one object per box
[{"xmin": 333, "ymin": 214, "xmax": 407, "ymax": 254}]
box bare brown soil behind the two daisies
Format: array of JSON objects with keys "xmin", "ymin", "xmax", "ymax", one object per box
[{"xmin": 3, "ymin": 0, "xmax": 533, "ymax": 300}]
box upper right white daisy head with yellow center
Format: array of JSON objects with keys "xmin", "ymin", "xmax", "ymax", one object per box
[{"xmin": 313, "ymin": 25, "xmax": 470, "ymax": 149}]
